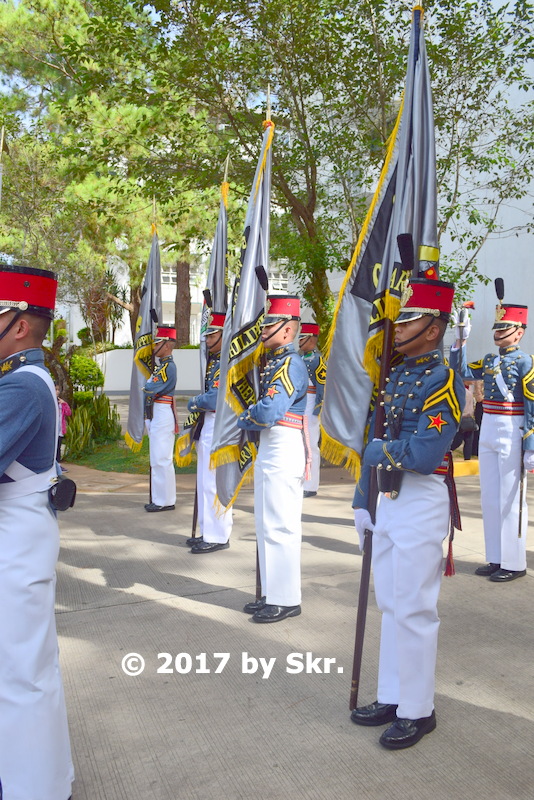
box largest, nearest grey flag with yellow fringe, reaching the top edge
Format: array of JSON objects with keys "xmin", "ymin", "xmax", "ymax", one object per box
[{"xmin": 321, "ymin": 6, "xmax": 439, "ymax": 478}]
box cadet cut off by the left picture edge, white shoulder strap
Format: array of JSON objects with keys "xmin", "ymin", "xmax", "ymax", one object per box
[{"xmin": 0, "ymin": 264, "xmax": 74, "ymax": 800}]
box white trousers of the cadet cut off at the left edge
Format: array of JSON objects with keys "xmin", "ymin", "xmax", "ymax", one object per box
[{"xmin": 0, "ymin": 492, "xmax": 74, "ymax": 800}]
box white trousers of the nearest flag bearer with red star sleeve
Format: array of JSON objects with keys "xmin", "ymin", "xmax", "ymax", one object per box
[{"xmin": 372, "ymin": 473, "xmax": 449, "ymax": 719}]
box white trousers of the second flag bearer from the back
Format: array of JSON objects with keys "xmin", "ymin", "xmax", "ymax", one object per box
[{"xmin": 197, "ymin": 411, "xmax": 232, "ymax": 544}]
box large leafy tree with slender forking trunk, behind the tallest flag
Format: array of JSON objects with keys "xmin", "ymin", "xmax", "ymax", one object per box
[{"xmin": 0, "ymin": 0, "xmax": 534, "ymax": 323}]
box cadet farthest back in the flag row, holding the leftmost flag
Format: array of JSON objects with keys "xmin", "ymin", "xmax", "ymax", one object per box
[{"xmin": 143, "ymin": 326, "xmax": 176, "ymax": 511}]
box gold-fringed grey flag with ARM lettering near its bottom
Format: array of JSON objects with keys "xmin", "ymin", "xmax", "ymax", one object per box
[{"xmin": 211, "ymin": 120, "xmax": 274, "ymax": 507}]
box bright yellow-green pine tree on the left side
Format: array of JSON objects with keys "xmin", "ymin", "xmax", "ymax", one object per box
[{"xmin": 0, "ymin": 0, "xmax": 236, "ymax": 341}]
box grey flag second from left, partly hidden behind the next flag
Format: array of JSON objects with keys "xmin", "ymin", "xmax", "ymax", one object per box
[{"xmin": 174, "ymin": 180, "xmax": 228, "ymax": 467}]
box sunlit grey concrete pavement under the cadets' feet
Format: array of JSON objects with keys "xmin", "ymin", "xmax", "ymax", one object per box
[{"xmin": 57, "ymin": 432, "xmax": 534, "ymax": 800}]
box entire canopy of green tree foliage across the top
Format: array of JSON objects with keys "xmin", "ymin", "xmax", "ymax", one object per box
[{"xmin": 0, "ymin": 0, "xmax": 534, "ymax": 330}]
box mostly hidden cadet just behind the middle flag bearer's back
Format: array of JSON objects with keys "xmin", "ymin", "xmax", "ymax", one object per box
[{"xmin": 299, "ymin": 322, "xmax": 326, "ymax": 497}]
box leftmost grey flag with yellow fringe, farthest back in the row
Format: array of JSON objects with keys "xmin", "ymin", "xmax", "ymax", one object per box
[{"xmin": 124, "ymin": 226, "xmax": 161, "ymax": 453}]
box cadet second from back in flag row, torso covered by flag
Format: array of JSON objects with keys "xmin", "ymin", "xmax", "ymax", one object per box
[{"xmin": 187, "ymin": 312, "xmax": 232, "ymax": 553}]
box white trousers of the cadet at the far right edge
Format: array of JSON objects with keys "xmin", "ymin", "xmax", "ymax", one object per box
[{"xmin": 478, "ymin": 414, "xmax": 528, "ymax": 570}]
